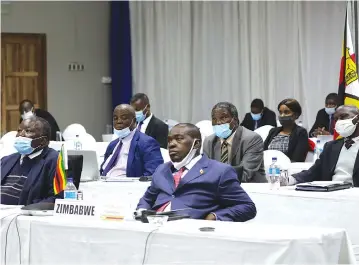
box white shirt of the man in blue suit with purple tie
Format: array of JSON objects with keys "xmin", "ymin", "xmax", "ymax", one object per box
[{"xmin": 102, "ymin": 130, "xmax": 136, "ymax": 178}]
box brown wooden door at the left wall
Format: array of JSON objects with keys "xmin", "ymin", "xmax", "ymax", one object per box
[{"xmin": 0, "ymin": 33, "xmax": 47, "ymax": 133}]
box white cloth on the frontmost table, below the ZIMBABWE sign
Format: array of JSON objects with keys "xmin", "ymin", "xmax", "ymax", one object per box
[{"xmin": 1, "ymin": 212, "xmax": 355, "ymax": 264}]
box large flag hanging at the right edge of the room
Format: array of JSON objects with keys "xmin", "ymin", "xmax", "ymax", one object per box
[{"xmin": 334, "ymin": 9, "xmax": 359, "ymax": 139}]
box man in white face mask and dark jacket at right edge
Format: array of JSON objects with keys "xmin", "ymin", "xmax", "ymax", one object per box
[{"xmin": 281, "ymin": 106, "xmax": 359, "ymax": 187}]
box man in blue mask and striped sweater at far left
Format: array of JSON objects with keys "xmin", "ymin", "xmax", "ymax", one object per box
[{"xmin": 1, "ymin": 116, "xmax": 58, "ymax": 205}]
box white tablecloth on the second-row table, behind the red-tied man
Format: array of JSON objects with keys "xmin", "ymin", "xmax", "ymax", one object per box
[{"xmin": 80, "ymin": 182, "xmax": 359, "ymax": 261}]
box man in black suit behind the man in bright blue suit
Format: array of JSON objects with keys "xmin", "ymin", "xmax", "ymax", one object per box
[{"xmin": 131, "ymin": 93, "xmax": 168, "ymax": 149}]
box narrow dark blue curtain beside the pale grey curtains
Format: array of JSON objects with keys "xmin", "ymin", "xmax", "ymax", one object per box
[{"xmin": 109, "ymin": 1, "xmax": 132, "ymax": 108}]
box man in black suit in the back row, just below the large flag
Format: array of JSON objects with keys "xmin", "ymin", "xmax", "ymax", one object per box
[{"xmin": 309, "ymin": 93, "xmax": 338, "ymax": 137}]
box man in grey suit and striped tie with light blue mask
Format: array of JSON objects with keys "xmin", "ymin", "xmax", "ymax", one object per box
[{"xmin": 203, "ymin": 102, "xmax": 267, "ymax": 182}]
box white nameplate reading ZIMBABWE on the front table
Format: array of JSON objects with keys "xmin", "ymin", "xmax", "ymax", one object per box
[{"xmin": 54, "ymin": 199, "xmax": 98, "ymax": 218}]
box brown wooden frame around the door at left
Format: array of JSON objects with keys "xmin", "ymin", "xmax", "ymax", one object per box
[{"xmin": 0, "ymin": 33, "xmax": 47, "ymax": 132}]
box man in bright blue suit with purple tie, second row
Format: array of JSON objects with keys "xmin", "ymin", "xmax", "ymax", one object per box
[{"xmin": 100, "ymin": 104, "xmax": 163, "ymax": 179}]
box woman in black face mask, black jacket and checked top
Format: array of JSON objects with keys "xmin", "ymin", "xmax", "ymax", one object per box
[{"xmin": 264, "ymin": 98, "xmax": 308, "ymax": 162}]
